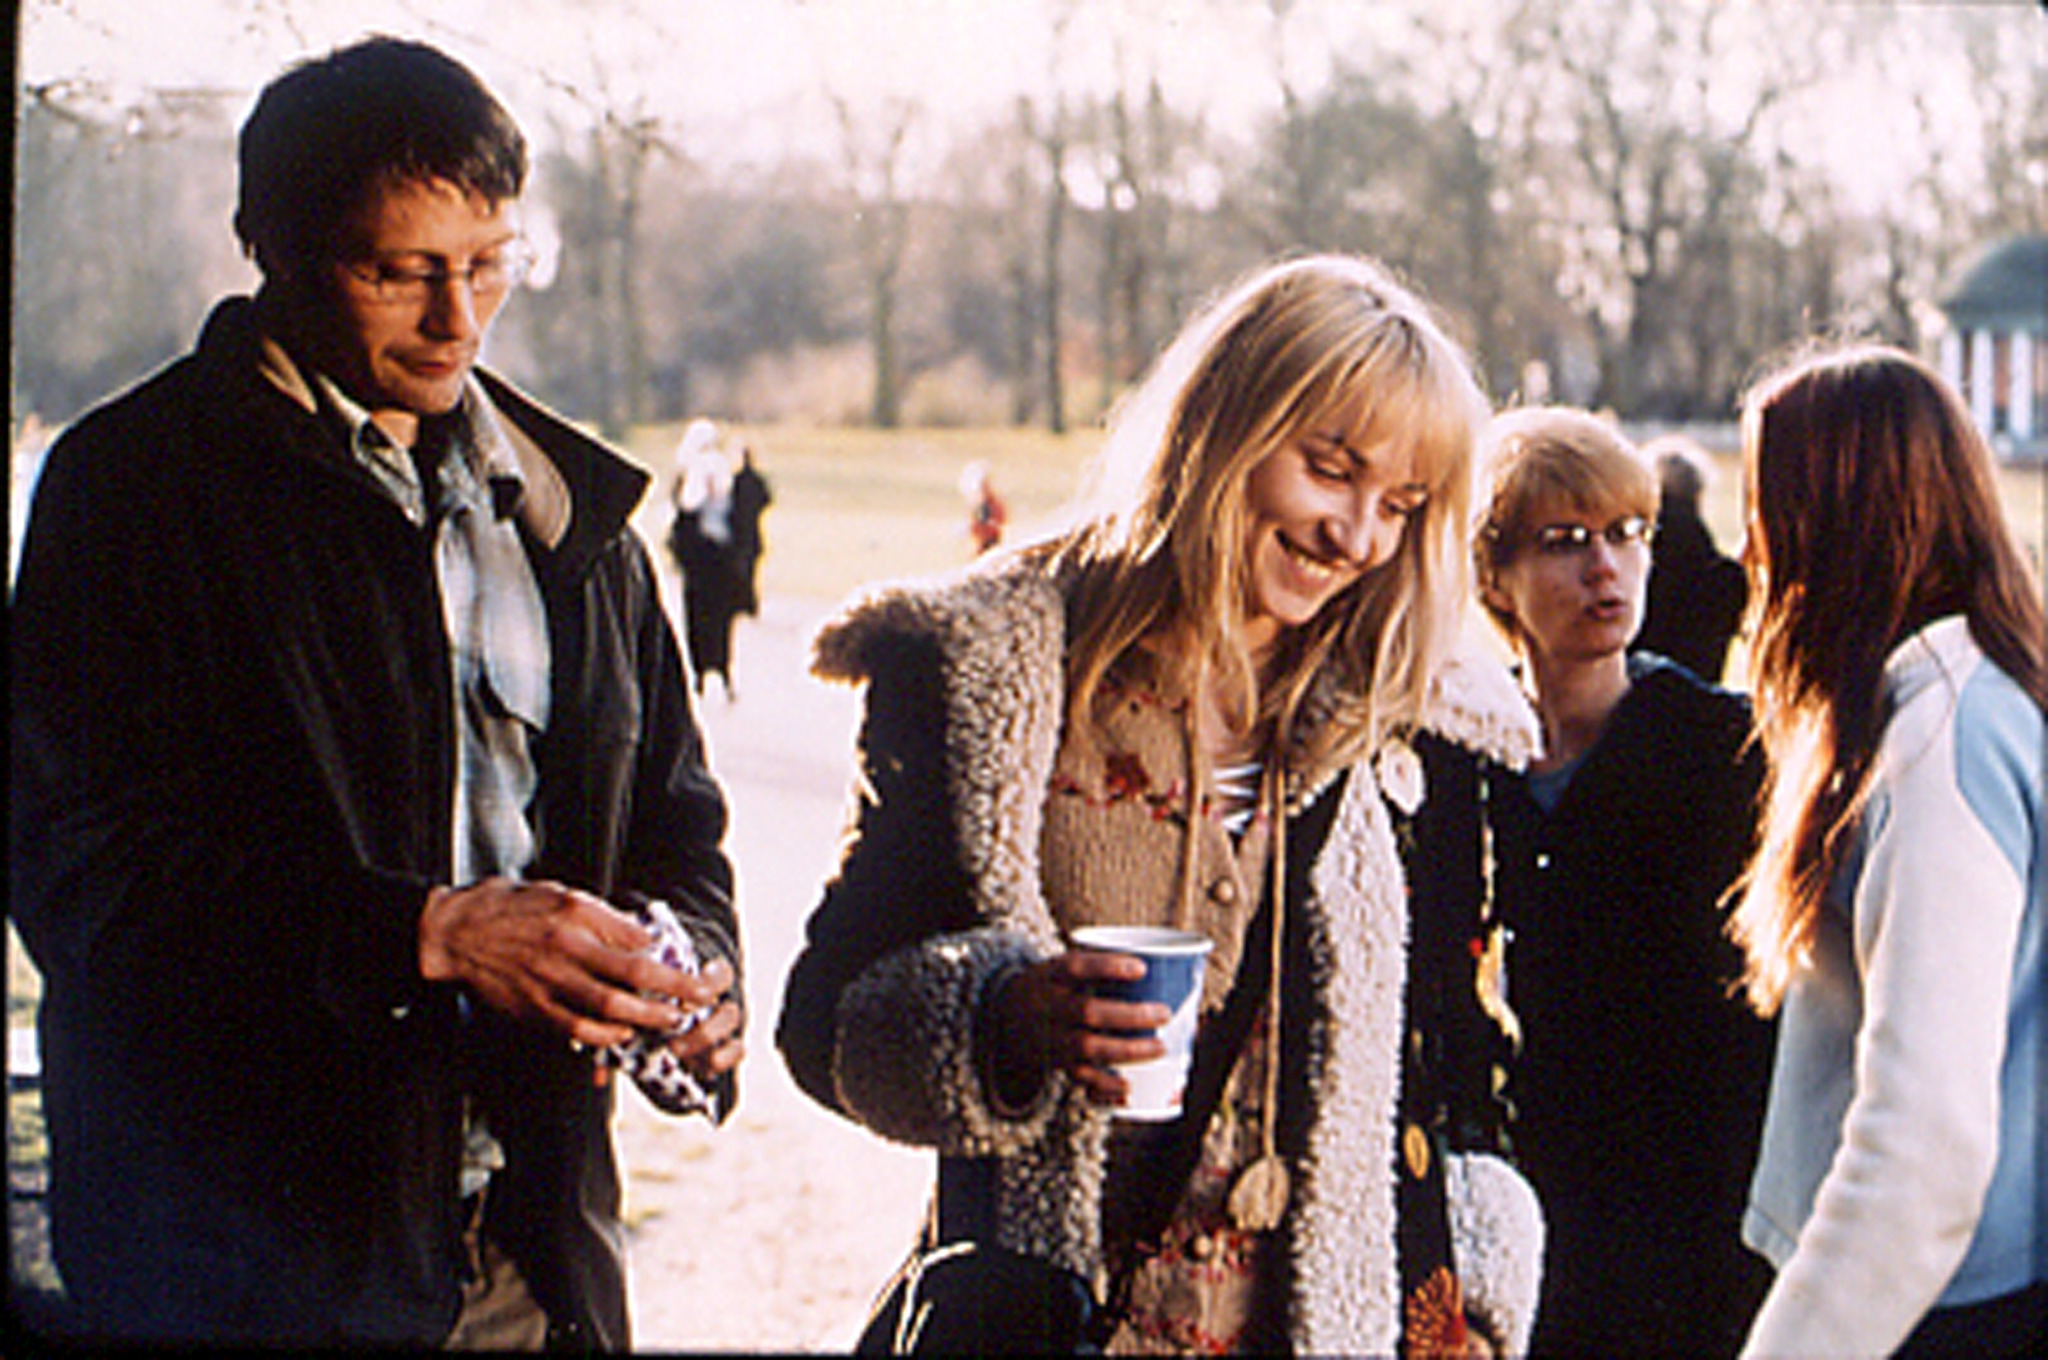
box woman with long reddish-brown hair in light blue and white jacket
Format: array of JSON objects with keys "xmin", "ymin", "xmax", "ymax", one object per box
[{"xmin": 1735, "ymin": 346, "xmax": 2048, "ymax": 1356}]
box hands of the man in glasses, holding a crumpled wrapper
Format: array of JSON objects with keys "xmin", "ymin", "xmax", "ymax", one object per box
[{"xmin": 420, "ymin": 879, "xmax": 720, "ymax": 1044}]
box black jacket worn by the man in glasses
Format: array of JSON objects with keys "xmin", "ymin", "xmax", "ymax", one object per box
[{"xmin": 10, "ymin": 299, "xmax": 737, "ymax": 1346}]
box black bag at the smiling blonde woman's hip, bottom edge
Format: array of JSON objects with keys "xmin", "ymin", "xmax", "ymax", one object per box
[{"xmin": 854, "ymin": 1157, "xmax": 1102, "ymax": 1356}]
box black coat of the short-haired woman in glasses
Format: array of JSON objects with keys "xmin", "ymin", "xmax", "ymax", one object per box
[{"xmin": 1491, "ymin": 657, "xmax": 1772, "ymax": 1356}]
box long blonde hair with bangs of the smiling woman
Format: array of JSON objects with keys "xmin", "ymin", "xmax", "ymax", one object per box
[{"xmin": 1051, "ymin": 256, "xmax": 1489, "ymax": 758}]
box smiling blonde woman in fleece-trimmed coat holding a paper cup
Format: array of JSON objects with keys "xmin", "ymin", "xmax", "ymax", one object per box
[{"xmin": 778, "ymin": 256, "xmax": 1540, "ymax": 1354}]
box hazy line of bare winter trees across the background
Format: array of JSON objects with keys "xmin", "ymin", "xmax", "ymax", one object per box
[{"xmin": 14, "ymin": 0, "xmax": 2048, "ymax": 434}]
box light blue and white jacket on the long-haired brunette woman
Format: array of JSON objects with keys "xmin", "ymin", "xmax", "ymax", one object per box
[{"xmin": 1743, "ymin": 619, "xmax": 2048, "ymax": 1356}]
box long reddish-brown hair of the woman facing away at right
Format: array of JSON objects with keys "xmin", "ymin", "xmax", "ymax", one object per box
[{"xmin": 1731, "ymin": 344, "xmax": 2048, "ymax": 1012}]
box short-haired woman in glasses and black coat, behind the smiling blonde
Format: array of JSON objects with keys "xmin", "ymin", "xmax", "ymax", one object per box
[{"xmin": 1475, "ymin": 408, "xmax": 1769, "ymax": 1356}]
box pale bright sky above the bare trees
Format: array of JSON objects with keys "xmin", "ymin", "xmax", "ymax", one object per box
[{"xmin": 20, "ymin": 0, "xmax": 2048, "ymax": 207}]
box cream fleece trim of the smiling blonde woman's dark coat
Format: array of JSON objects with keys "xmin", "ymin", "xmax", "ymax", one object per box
[{"xmin": 778, "ymin": 561, "xmax": 1542, "ymax": 1354}]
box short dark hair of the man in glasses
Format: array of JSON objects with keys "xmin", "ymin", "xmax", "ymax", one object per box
[{"xmin": 236, "ymin": 37, "xmax": 526, "ymax": 274}]
